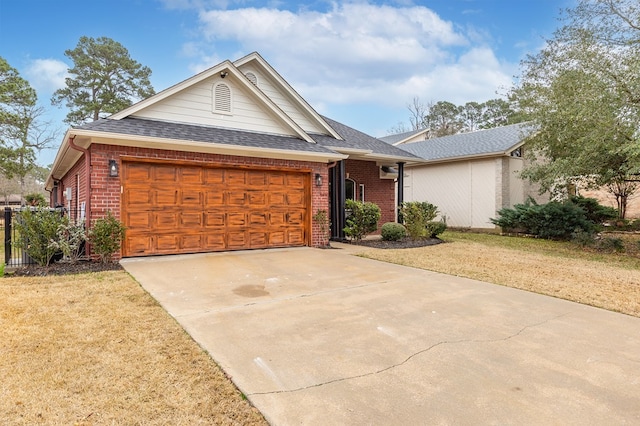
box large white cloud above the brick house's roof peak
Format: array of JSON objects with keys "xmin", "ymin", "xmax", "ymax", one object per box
[{"xmin": 185, "ymin": 2, "xmax": 514, "ymax": 124}]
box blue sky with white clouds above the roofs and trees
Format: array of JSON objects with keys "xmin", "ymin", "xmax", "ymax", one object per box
[{"xmin": 0, "ymin": 0, "xmax": 576, "ymax": 165}]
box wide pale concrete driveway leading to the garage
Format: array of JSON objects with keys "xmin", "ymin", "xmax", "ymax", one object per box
[{"xmin": 122, "ymin": 245, "xmax": 640, "ymax": 425}]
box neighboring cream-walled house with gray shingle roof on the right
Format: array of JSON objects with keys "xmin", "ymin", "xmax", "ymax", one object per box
[{"xmin": 398, "ymin": 124, "xmax": 546, "ymax": 229}]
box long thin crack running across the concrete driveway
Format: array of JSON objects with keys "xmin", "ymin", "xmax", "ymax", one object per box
[{"xmin": 246, "ymin": 313, "xmax": 569, "ymax": 396}]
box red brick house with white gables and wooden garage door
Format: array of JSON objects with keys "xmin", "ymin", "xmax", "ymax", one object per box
[{"xmin": 46, "ymin": 53, "xmax": 418, "ymax": 257}]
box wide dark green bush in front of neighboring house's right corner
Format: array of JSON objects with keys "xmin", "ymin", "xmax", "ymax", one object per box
[{"xmin": 491, "ymin": 199, "xmax": 595, "ymax": 240}]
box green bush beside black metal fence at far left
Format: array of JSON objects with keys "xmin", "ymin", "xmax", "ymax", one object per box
[{"xmin": 14, "ymin": 208, "xmax": 65, "ymax": 266}]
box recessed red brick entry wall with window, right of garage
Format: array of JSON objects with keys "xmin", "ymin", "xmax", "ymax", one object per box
[{"xmin": 345, "ymin": 160, "xmax": 396, "ymax": 232}]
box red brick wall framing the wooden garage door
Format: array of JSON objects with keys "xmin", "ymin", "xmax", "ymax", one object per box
[{"xmin": 59, "ymin": 144, "xmax": 329, "ymax": 251}]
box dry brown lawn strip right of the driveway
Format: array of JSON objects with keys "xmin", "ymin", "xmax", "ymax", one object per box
[{"xmin": 363, "ymin": 232, "xmax": 640, "ymax": 317}]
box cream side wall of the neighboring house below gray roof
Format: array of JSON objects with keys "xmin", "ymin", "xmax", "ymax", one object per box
[{"xmin": 404, "ymin": 160, "xmax": 497, "ymax": 228}]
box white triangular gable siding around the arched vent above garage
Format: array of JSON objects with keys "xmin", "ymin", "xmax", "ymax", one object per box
[{"xmin": 125, "ymin": 76, "xmax": 295, "ymax": 136}]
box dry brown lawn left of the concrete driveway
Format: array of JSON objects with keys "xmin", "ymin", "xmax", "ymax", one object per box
[{"xmin": 0, "ymin": 271, "xmax": 266, "ymax": 425}]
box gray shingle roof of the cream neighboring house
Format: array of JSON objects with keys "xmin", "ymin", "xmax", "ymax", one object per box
[{"xmin": 399, "ymin": 123, "xmax": 533, "ymax": 164}]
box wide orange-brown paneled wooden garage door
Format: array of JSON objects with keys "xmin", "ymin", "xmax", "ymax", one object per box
[{"xmin": 122, "ymin": 162, "xmax": 309, "ymax": 256}]
